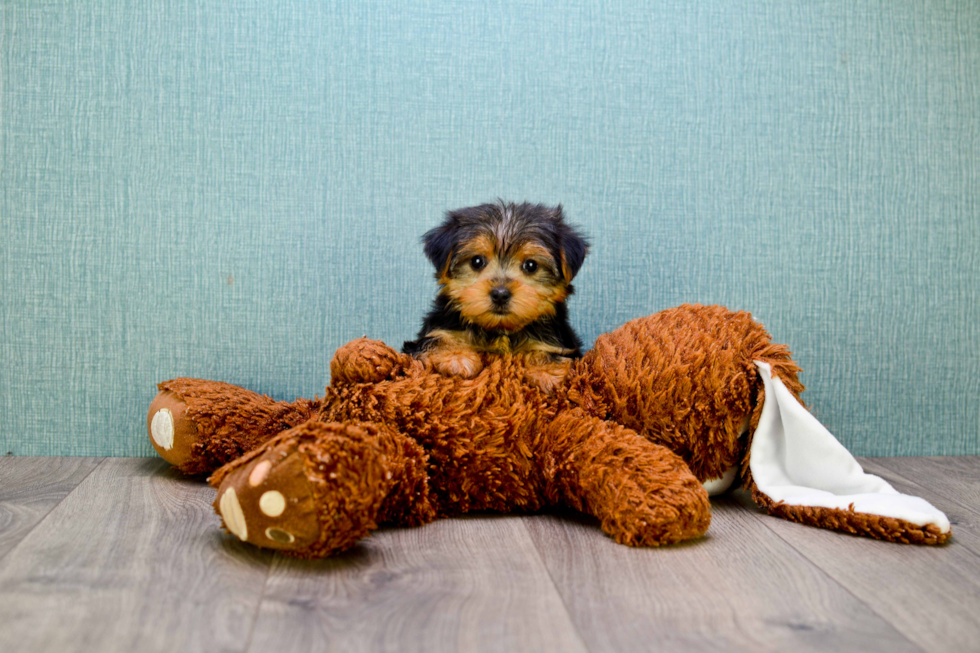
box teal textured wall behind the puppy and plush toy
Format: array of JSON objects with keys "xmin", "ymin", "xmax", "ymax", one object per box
[{"xmin": 0, "ymin": 0, "xmax": 980, "ymax": 455}]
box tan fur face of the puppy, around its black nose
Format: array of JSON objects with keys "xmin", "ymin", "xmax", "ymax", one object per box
[{"xmin": 439, "ymin": 234, "xmax": 568, "ymax": 331}]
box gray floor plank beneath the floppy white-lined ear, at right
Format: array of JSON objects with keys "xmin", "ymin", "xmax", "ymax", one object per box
[{"xmin": 740, "ymin": 459, "xmax": 980, "ymax": 652}]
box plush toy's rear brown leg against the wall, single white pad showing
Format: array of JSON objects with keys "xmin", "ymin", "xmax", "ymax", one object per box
[{"xmin": 146, "ymin": 379, "xmax": 316, "ymax": 474}]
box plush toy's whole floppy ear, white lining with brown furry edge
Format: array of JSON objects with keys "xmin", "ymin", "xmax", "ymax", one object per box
[{"xmin": 748, "ymin": 361, "xmax": 951, "ymax": 544}]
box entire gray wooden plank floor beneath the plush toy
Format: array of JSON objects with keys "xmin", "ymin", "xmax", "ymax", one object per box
[{"xmin": 0, "ymin": 457, "xmax": 980, "ymax": 653}]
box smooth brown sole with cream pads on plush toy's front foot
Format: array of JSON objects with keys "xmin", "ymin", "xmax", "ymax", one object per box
[{"xmin": 214, "ymin": 446, "xmax": 320, "ymax": 551}]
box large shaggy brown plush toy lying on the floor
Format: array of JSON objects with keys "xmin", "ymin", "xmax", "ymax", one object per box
[{"xmin": 147, "ymin": 305, "xmax": 950, "ymax": 557}]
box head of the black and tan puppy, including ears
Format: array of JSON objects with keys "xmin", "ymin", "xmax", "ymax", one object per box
[{"xmin": 423, "ymin": 202, "xmax": 589, "ymax": 331}]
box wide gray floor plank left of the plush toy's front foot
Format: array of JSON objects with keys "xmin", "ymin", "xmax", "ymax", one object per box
[{"xmin": 0, "ymin": 458, "xmax": 272, "ymax": 653}]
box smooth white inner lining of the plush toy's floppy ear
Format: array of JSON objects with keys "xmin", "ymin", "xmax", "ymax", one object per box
[{"xmin": 749, "ymin": 361, "xmax": 949, "ymax": 533}]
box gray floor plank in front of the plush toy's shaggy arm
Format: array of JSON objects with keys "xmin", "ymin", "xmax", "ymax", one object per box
[{"xmin": 527, "ymin": 498, "xmax": 920, "ymax": 653}]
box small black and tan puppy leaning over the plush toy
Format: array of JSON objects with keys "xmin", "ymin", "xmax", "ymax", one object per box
[{"xmin": 402, "ymin": 202, "xmax": 589, "ymax": 392}]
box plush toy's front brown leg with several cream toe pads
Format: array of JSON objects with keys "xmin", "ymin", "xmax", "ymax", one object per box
[{"xmin": 210, "ymin": 421, "xmax": 435, "ymax": 558}]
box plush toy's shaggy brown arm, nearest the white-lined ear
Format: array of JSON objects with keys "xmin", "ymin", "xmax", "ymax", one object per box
[{"xmin": 546, "ymin": 409, "xmax": 711, "ymax": 546}]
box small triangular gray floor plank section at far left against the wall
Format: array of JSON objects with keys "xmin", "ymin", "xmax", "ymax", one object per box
[{"xmin": 0, "ymin": 456, "xmax": 102, "ymax": 558}]
